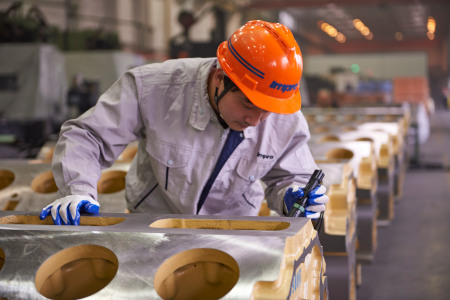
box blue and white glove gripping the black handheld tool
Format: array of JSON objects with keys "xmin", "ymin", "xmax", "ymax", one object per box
[{"xmin": 284, "ymin": 185, "xmax": 330, "ymax": 219}]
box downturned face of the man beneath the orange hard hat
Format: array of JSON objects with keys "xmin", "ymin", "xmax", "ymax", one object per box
[{"xmin": 219, "ymin": 81, "xmax": 270, "ymax": 131}]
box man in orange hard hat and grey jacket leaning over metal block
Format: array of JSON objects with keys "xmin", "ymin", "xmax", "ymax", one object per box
[{"xmin": 40, "ymin": 21, "xmax": 328, "ymax": 225}]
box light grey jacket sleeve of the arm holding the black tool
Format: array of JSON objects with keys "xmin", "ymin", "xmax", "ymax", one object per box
[{"xmin": 262, "ymin": 113, "xmax": 318, "ymax": 215}]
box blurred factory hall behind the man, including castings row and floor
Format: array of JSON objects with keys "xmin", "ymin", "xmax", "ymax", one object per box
[{"xmin": 0, "ymin": 0, "xmax": 450, "ymax": 300}]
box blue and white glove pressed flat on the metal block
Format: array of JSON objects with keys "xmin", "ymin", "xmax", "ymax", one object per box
[{"xmin": 39, "ymin": 195, "xmax": 100, "ymax": 225}]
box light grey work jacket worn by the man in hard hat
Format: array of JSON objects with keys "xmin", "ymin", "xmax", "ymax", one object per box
[{"xmin": 53, "ymin": 58, "xmax": 317, "ymax": 216}]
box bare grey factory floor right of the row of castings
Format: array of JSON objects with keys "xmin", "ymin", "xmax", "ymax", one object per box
[{"xmin": 356, "ymin": 110, "xmax": 450, "ymax": 300}]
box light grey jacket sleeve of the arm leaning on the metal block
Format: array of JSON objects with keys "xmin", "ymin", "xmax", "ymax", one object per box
[{"xmin": 52, "ymin": 69, "xmax": 143, "ymax": 199}]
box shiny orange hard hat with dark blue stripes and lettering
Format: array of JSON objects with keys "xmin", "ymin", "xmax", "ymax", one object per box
[{"xmin": 217, "ymin": 20, "xmax": 303, "ymax": 114}]
